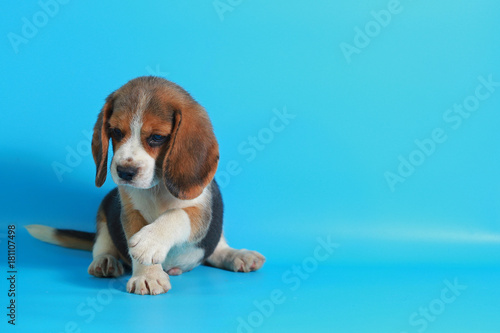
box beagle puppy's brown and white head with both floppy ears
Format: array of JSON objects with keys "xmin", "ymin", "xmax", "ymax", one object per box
[{"xmin": 92, "ymin": 76, "xmax": 219, "ymax": 200}]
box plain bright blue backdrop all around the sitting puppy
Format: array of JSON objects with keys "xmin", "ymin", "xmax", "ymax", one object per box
[{"xmin": 0, "ymin": 0, "xmax": 500, "ymax": 332}]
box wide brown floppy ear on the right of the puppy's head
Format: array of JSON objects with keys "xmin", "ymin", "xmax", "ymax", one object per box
[{"xmin": 162, "ymin": 105, "xmax": 219, "ymax": 200}]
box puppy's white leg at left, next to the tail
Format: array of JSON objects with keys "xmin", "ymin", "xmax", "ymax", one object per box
[{"xmin": 88, "ymin": 213, "xmax": 123, "ymax": 277}]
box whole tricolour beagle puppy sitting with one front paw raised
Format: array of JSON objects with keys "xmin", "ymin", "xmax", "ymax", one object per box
[{"xmin": 26, "ymin": 76, "xmax": 265, "ymax": 295}]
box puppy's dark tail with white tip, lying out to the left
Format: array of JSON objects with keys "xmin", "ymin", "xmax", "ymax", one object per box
[{"xmin": 25, "ymin": 224, "xmax": 95, "ymax": 251}]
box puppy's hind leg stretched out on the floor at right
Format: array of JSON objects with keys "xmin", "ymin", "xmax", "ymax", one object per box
[{"xmin": 205, "ymin": 235, "xmax": 266, "ymax": 273}]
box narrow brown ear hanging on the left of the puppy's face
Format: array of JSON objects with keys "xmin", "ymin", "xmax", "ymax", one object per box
[{"xmin": 92, "ymin": 94, "xmax": 113, "ymax": 187}]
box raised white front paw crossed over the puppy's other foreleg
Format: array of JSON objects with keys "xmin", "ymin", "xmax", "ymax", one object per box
[{"xmin": 128, "ymin": 224, "xmax": 170, "ymax": 265}]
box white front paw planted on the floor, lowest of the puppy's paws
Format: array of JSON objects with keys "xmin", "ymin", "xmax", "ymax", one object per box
[{"xmin": 127, "ymin": 269, "xmax": 172, "ymax": 295}]
